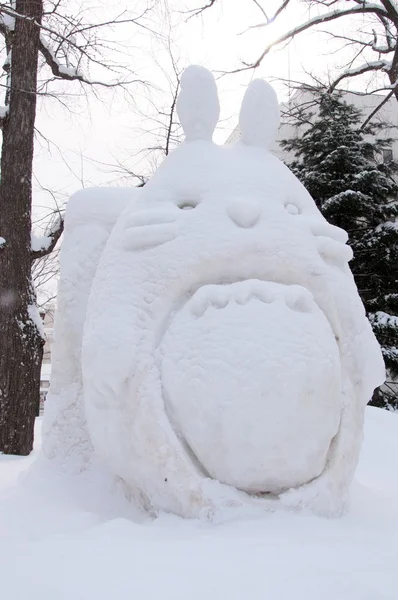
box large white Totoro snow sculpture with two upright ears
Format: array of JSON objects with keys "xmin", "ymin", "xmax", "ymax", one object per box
[{"xmin": 44, "ymin": 67, "xmax": 384, "ymax": 517}]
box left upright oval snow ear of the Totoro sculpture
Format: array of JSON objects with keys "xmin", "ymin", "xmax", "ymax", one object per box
[{"xmin": 177, "ymin": 65, "xmax": 220, "ymax": 142}]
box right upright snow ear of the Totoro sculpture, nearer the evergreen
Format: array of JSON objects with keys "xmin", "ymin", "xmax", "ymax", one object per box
[{"xmin": 239, "ymin": 79, "xmax": 280, "ymax": 150}]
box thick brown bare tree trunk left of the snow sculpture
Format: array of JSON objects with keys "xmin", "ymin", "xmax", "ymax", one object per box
[{"xmin": 0, "ymin": 0, "xmax": 43, "ymax": 455}]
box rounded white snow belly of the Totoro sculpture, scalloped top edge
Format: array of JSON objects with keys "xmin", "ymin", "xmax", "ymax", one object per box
[{"xmin": 161, "ymin": 282, "xmax": 340, "ymax": 493}]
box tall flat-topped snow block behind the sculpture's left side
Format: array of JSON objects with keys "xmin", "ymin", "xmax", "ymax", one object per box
[{"xmin": 43, "ymin": 188, "xmax": 140, "ymax": 471}]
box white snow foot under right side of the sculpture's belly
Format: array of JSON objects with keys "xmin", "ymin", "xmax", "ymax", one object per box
[{"xmin": 279, "ymin": 476, "xmax": 347, "ymax": 517}]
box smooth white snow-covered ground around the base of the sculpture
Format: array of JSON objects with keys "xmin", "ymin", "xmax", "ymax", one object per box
[{"xmin": 0, "ymin": 408, "xmax": 398, "ymax": 600}]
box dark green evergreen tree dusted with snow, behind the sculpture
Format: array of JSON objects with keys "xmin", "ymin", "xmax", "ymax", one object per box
[{"xmin": 282, "ymin": 92, "xmax": 398, "ymax": 408}]
